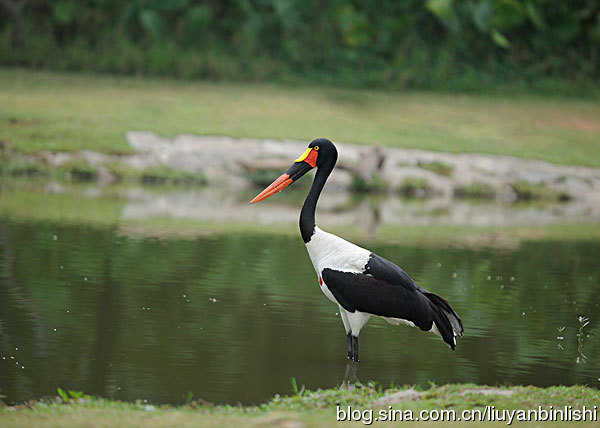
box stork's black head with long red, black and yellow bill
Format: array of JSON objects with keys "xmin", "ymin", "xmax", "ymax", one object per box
[{"xmin": 250, "ymin": 138, "xmax": 337, "ymax": 204}]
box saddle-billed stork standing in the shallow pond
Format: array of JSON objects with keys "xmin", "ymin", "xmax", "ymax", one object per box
[{"xmin": 251, "ymin": 138, "xmax": 463, "ymax": 361}]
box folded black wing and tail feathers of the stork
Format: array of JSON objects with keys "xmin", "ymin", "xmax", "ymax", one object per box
[{"xmin": 321, "ymin": 254, "xmax": 463, "ymax": 349}]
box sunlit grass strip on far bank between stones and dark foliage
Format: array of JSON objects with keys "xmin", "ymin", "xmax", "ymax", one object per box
[{"xmin": 0, "ymin": 69, "xmax": 600, "ymax": 166}]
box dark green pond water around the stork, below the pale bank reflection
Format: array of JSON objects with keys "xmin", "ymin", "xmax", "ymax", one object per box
[{"xmin": 0, "ymin": 218, "xmax": 600, "ymax": 403}]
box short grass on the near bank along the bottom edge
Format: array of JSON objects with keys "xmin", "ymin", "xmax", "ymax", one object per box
[{"xmin": 0, "ymin": 385, "xmax": 600, "ymax": 427}]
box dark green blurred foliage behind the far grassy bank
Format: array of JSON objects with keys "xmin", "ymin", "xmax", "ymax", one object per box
[{"xmin": 0, "ymin": 0, "xmax": 600, "ymax": 96}]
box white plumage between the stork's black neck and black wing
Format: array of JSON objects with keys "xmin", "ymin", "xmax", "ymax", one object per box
[{"xmin": 306, "ymin": 226, "xmax": 371, "ymax": 275}]
